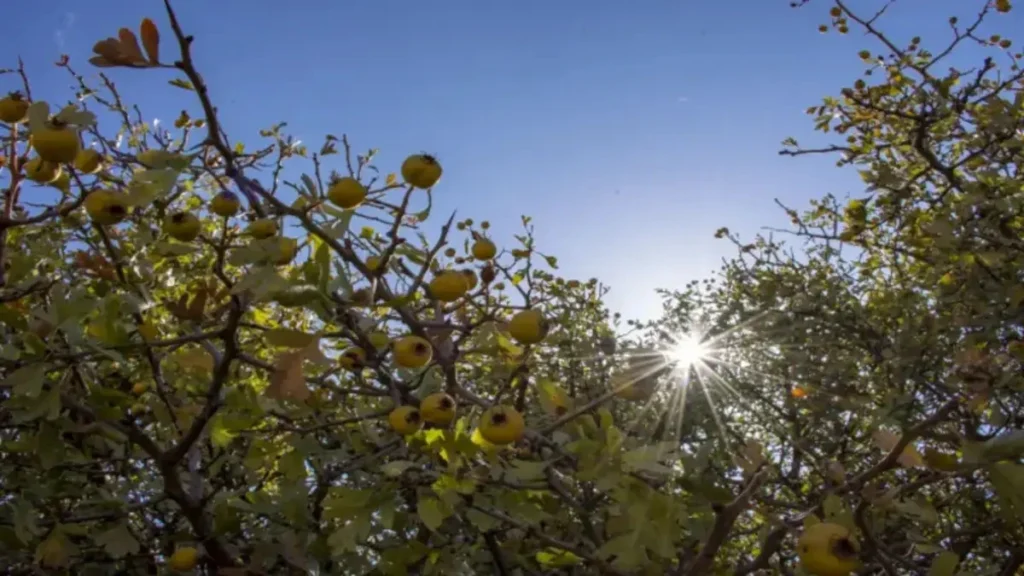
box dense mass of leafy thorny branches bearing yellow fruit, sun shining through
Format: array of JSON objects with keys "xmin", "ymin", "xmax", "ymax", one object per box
[{"xmin": 0, "ymin": 1, "xmax": 1024, "ymax": 575}]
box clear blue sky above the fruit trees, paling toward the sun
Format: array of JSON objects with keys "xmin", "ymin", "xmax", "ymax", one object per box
[{"xmin": 0, "ymin": 0, "xmax": 1024, "ymax": 317}]
